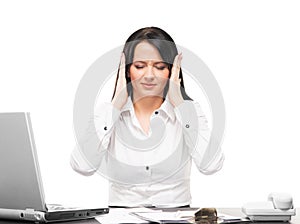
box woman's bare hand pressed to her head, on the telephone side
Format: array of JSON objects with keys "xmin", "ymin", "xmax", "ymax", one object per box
[{"xmin": 168, "ymin": 53, "xmax": 184, "ymax": 107}]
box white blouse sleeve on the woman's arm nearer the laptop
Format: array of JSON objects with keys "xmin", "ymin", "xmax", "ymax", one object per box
[{"xmin": 70, "ymin": 103, "xmax": 120, "ymax": 176}]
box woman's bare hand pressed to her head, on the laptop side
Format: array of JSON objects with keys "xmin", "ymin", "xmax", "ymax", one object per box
[{"xmin": 111, "ymin": 53, "xmax": 128, "ymax": 110}]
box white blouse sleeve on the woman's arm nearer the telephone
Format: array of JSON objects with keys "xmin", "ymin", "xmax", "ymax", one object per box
[{"xmin": 175, "ymin": 100, "xmax": 224, "ymax": 174}]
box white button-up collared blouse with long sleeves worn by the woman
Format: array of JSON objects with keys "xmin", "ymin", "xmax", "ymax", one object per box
[{"xmin": 70, "ymin": 97, "xmax": 224, "ymax": 207}]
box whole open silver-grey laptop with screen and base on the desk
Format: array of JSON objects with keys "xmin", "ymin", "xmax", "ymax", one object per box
[{"xmin": 0, "ymin": 112, "xmax": 109, "ymax": 222}]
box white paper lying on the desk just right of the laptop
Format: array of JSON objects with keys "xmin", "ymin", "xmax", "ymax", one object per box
[{"xmin": 96, "ymin": 207, "xmax": 161, "ymax": 224}]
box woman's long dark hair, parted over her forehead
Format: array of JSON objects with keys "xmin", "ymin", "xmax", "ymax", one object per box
[{"xmin": 112, "ymin": 27, "xmax": 192, "ymax": 100}]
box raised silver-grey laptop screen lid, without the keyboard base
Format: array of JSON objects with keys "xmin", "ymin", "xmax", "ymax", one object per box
[{"xmin": 0, "ymin": 112, "xmax": 46, "ymax": 211}]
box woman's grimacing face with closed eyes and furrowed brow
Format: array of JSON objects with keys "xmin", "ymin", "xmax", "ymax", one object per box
[{"xmin": 129, "ymin": 41, "xmax": 170, "ymax": 100}]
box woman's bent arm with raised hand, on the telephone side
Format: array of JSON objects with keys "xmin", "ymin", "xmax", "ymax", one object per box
[{"xmin": 168, "ymin": 54, "xmax": 224, "ymax": 174}]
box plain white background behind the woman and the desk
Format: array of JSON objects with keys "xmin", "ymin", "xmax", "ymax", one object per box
[{"xmin": 0, "ymin": 0, "xmax": 300, "ymax": 207}]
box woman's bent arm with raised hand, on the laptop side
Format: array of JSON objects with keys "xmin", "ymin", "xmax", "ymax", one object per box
[{"xmin": 70, "ymin": 53, "xmax": 128, "ymax": 176}]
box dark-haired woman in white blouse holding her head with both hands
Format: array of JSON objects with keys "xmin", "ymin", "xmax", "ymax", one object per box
[{"xmin": 71, "ymin": 27, "xmax": 224, "ymax": 207}]
